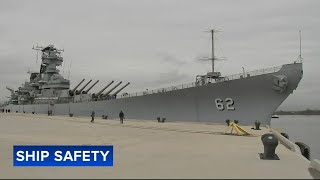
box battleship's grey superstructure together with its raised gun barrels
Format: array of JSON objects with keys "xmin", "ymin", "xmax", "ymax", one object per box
[{"xmin": 7, "ymin": 45, "xmax": 130, "ymax": 105}]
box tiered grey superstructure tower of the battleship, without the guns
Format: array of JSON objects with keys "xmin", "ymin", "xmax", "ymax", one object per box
[{"xmin": 7, "ymin": 45, "xmax": 70, "ymax": 105}]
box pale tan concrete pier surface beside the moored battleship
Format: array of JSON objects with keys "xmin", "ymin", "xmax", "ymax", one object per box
[{"xmin": 0, "ymin": 113, "xmax": 313, "ymax": 179}]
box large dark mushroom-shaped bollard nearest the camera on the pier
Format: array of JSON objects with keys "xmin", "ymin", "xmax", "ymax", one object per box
[{"xmin": 260, "ymin": 133, "xmax": 279, "ymax": 160}]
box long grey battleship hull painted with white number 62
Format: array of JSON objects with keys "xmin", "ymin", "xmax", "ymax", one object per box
[{"xmin": 6, "ymin": 63, "xmax": 303, "ymax": 125}]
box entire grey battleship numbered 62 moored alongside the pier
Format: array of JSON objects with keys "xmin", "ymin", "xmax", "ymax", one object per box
[{"xmin": 3, "ymin": 30, "xmax": 303, "ymax": 125}]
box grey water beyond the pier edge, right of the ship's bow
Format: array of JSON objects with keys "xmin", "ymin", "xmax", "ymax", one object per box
[{"xmin": 271, "ymin": 115, "xmax": 320, "ymax": 160}]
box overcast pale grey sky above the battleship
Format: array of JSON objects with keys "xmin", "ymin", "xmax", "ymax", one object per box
[{"xmin": 0, "ymin": 0, "xmax": 320, "ymax": 110}]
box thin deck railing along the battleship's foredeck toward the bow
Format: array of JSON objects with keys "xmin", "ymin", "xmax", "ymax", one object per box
[{"xmin": 117, "ymin": 66, "xmax": 282, "ymax": 99}]
